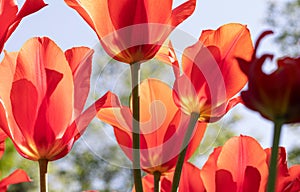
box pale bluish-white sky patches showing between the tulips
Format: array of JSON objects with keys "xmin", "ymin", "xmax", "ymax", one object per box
[{"xmin": 5, "ymin": 0, "xmax": 297, "ymax": 156}]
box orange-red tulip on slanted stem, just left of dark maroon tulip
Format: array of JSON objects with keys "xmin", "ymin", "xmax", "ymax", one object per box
[{"xmin": 157, "ymin": 24, "xmax": 253, "ymax": 122}]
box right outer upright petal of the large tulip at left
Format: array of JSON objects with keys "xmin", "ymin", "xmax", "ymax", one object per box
[{"xmin": 65, "ymin": 47, "xmax": 94, "ymax": 120}]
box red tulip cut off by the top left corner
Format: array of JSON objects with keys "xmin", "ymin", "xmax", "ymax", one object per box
[{"xmin": 0, "ymin": 0, "xmax": 46, "ymax": 53}]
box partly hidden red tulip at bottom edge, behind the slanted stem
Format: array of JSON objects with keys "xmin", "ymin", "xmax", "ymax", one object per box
[{"xmin": 132, "ymin": 162, "xmax": 205, "ymax": 192}]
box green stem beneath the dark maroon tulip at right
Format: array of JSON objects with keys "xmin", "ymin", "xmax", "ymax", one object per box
[{"xmin": 267, "ymin": 121, "xmax": 283, "ymax": 192}]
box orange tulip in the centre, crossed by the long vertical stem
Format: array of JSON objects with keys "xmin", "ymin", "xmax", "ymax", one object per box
[{"xmin": 98, "ymin": 79, "xmax": 206, "ymax": 174}]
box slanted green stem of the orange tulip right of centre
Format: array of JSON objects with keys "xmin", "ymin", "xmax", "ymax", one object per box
[{"xmin": 172, "ymin": 112, "xmax": 200, "ymax": 192}]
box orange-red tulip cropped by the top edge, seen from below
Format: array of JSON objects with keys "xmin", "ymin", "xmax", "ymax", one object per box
[{"xmin": 65, "ymin": 0, "xmax": 196, "ymax": 64}]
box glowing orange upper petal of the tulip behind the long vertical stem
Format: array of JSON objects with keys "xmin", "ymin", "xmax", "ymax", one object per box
[{"xmin": 140, "ymin": 79, "xmax": 178, "ymax": 147}]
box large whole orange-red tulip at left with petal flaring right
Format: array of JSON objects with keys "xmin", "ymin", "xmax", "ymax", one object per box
[{"xmin": 0, "ymin": 37, "xmax": 115, "ymax": 161}]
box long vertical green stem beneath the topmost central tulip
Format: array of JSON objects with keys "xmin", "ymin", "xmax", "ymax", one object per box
[{"xmin": 130, "ymin": 63, "xmax": 143, "ymax": 192}]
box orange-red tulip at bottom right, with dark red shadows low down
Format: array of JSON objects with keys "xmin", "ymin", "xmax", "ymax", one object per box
[{"xmin": 201, "ymin": 136, "xmax": 268, "ymax": 192}]
